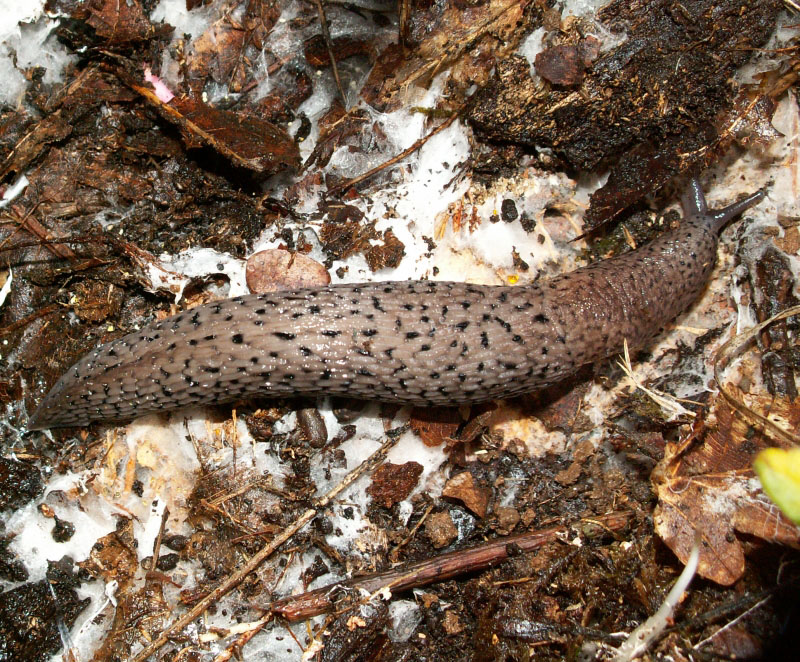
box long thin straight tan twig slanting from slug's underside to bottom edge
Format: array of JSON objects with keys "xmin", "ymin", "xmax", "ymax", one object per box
[{"xmin": 129, "ymin": 426, "xmax": 407, "ymax": 662}]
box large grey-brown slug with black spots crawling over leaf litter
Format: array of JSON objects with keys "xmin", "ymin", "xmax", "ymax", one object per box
[{"xmin": 29, "ymin": 181, "xmax": 763, "ymax": 429}]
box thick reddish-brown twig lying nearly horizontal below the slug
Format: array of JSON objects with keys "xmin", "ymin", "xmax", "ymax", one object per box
[{"xmin": 266, "ymin": 512, "xmax": 630, "ymax": 622}]
